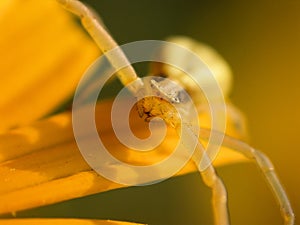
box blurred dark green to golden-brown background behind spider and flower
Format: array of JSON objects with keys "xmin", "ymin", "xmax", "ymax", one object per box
[{"xmin": 18, "ymin": 0, "xmax": 300, "ymax": 225}]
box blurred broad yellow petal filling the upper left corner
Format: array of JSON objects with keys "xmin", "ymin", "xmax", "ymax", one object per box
[{"xmin": 0, "ymin": 0, "xmax": 100, "ymax": 132}]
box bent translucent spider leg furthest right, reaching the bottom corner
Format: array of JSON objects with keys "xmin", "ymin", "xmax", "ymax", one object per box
[{"xmin": 200, "ymin": 128, "xmax": 295, "ymax": 225}]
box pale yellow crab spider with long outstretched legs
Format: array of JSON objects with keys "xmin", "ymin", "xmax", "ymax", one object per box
[{"xmin": 57, "ymin": 0, "xmax": 294, "ymax": 225}]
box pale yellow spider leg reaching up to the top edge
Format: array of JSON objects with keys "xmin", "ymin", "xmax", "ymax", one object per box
[{"xmin": 57, "ymin": 0, "xmax": 142, "ymax": 93}]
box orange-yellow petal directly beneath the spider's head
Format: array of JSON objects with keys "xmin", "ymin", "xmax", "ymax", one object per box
[{"xmin": 0, "ymin": 101, "xmax": 244, "ymax": 214}]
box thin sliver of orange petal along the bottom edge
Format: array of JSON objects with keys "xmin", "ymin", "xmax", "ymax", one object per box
[{"xmin": 1, "ymin": 219, "xmax": 145, "ymax": 225}]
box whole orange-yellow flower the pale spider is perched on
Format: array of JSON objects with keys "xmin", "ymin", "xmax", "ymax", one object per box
[{"xmin": 0, "ymin": 0, "xmax": 247, "ymax": 225}]
